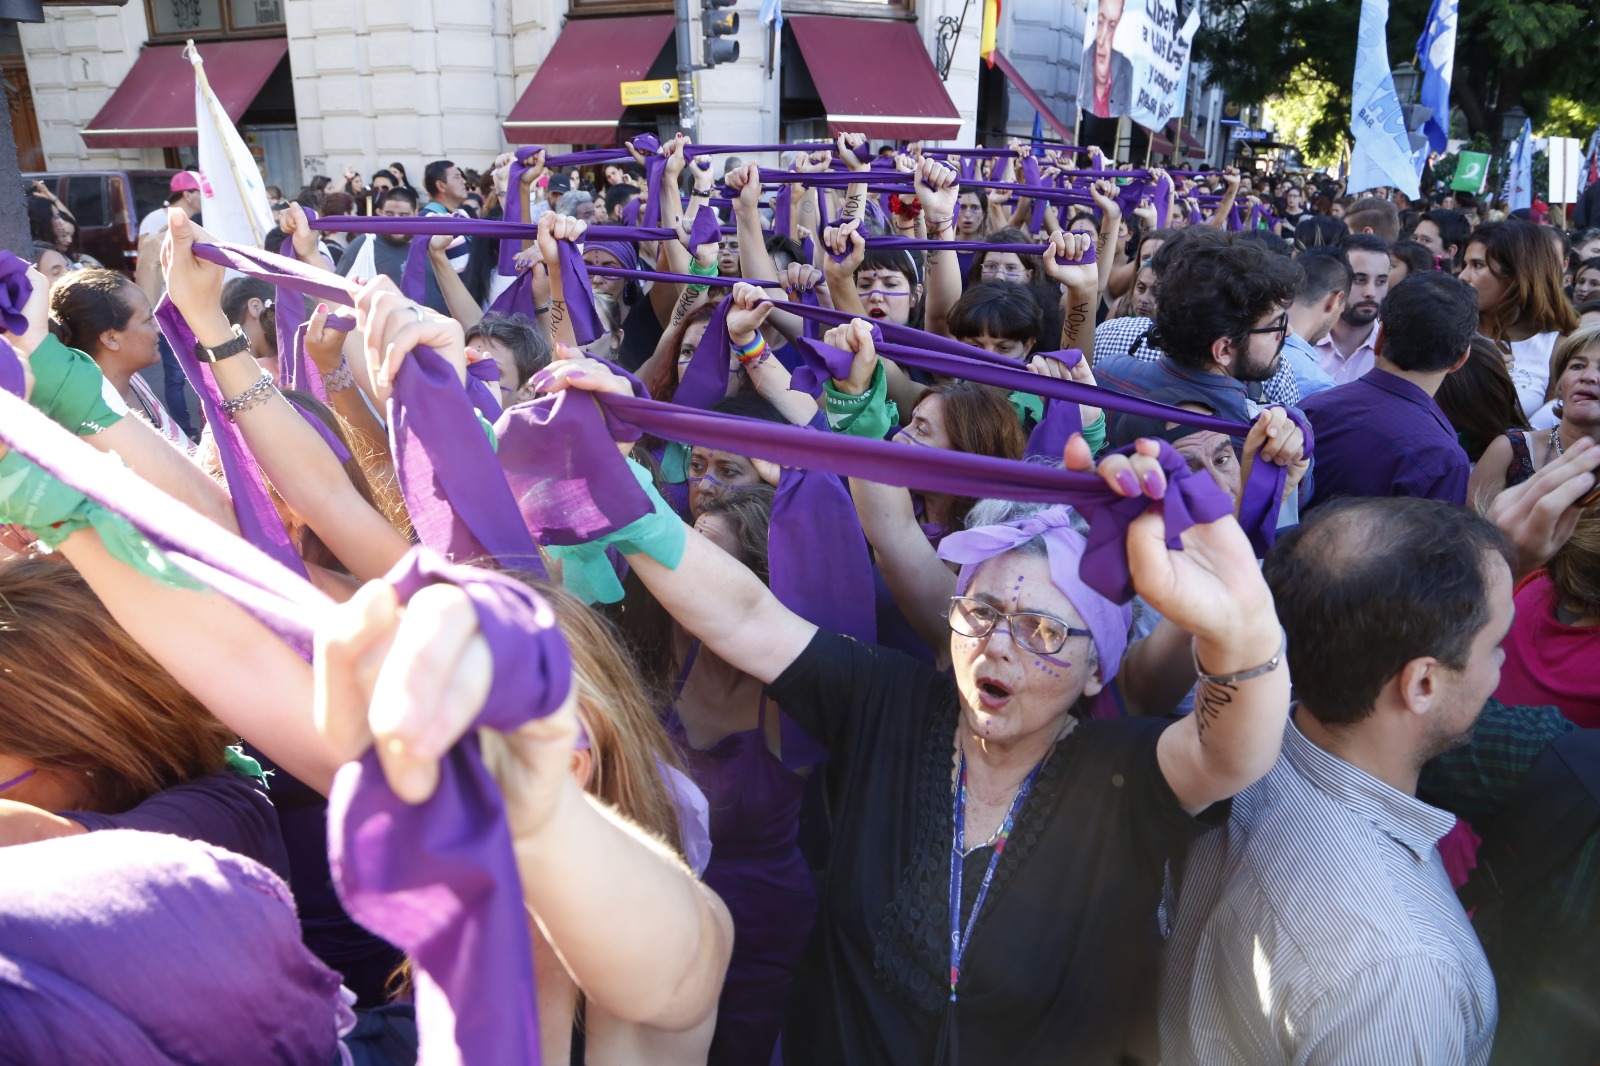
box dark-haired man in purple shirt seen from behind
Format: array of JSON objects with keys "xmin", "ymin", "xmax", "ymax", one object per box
[{"xmin": 1301, "ymin": 271, "xmax": 1478, "ymax": 506}]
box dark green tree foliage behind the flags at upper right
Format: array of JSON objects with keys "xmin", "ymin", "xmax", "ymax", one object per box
[{"xmin": 1195, "ymin": 0, "xmax": 1600, "ymax": 157}]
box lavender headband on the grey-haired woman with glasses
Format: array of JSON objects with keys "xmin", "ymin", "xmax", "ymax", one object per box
[{"xmin": 939, "ymin": 507, "xmax": 1133, "ymax": 685}]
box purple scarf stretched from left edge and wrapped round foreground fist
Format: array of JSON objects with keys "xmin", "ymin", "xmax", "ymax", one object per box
[{"xmin": 0, "ymin": 337, "xmax": 571, "ymax": 1066}]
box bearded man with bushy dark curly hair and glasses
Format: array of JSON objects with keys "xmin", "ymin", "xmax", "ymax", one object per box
[{"xmin": 1094, "ymin": 235, "xmax": 1302, "ymax": 423}]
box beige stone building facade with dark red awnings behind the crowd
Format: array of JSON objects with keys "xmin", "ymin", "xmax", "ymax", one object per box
[{"xmin": 19, "ymin": 0, "xmax": 998, "ymax": 186}]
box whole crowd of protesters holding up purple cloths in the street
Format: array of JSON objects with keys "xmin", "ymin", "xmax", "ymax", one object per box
[{"xmin": 0, "ymin": 134, "xmax": 1600, "ymax": 1066}]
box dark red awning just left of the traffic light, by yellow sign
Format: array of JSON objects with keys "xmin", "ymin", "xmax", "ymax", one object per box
[{"xmin": 504, "ymin": 14, "xmax": 672, "ymax": 146}]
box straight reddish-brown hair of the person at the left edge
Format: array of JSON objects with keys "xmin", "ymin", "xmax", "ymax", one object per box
[{"xmin": 0, "ymin": 559, "xmax": 238, "ymax": 813}]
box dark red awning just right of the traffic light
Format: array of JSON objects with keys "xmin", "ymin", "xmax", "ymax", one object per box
[{"xmin": 787, "ymin": 14, "xmax": 962, "ymax": 141}]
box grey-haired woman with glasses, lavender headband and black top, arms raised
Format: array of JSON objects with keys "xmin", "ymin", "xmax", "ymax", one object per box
[{"xmin": 550, "ymin": 331, "xmax": 1288, "ymax": 1066}]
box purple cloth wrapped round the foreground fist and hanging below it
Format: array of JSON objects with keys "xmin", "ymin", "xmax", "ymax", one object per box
[{"xmin": 328, "ymin": 551, "xmax": 573, "ymax": 1066}]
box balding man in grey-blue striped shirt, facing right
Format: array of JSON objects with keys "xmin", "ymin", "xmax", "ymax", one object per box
[{"xmin": 1162, "ymin": 498, "xmax": 1512, "ymax": 1066}]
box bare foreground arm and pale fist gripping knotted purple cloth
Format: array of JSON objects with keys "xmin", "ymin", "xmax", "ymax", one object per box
[{"xmin": 317, "ymin": 583, "xmax": 733, "ymax": 1032}]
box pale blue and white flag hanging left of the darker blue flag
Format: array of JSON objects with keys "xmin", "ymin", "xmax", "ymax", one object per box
[{"xmin": 1349, "ymin": 0, "xmax": 1421, "ymax": 198}]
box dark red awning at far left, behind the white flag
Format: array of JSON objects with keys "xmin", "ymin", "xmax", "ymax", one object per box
[{"xmin": 82, "ymin": 37, "xmax": 290, "ymax": 149}]
